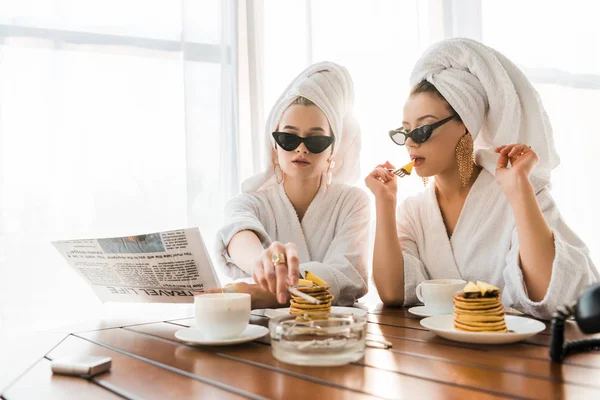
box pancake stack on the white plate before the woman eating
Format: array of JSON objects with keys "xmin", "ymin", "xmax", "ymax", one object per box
[{"xmin": 454, "ymin": 281, "xmax": 507, "ymax": 333}]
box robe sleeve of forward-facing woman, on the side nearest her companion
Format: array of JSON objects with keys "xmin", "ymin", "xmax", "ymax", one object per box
[{"xmin": 300, "ymin": 188, "xmax": 370, "ymax": 306}]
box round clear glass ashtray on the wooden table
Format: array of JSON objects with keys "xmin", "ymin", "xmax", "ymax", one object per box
[{"xmin": 269, "ymin": 313, "xmax": 367, "ymax": 366}]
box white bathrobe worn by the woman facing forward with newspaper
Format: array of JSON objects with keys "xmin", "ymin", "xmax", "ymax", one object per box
[{"xmin": 217, "ymin": 184, "xmax": 370, "ymax": 305}]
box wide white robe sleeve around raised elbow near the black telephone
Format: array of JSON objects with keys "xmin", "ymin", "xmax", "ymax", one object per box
[{"xmin": 502, "ymin": 187, "xmax": 599, "ymax": 319}]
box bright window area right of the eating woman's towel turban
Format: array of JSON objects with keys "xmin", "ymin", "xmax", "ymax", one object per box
[{"xmin": 482, "ymin": 0, "xmax": 600, "ymax": 260}]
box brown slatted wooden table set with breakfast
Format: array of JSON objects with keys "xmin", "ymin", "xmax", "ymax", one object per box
[{"xmin": 2, "ymin": 306, "xmax": 600, "ymax": 400}]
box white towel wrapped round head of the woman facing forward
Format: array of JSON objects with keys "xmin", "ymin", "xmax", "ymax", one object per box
[{"xmin": 242, "ymin": 62, "xmax": 360, "ymax": 193}]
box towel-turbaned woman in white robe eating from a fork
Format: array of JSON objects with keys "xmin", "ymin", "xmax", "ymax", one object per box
[{"xmin": 365, "ymin": 38, "xmax": 598, "ymax": 318}]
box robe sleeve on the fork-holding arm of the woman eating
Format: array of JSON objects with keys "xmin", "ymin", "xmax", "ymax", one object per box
[{"xmin": 396, "ymin": 198, "xmax": 430, "ymax": 305}]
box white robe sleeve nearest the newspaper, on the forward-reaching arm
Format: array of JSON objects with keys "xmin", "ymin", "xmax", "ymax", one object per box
[{"xmin": 216, "ymin": 194, "xmax": 272, "ymax": 279}]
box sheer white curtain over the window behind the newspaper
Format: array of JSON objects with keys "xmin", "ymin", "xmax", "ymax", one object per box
[{"xmin": 0, "ymin": 0, "xmax": 240, "ymax": 332}]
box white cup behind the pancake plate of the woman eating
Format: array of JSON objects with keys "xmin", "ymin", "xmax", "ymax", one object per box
[{"xmin": 416, "ymin": 279, "xmax": 467, "ymax": 314}]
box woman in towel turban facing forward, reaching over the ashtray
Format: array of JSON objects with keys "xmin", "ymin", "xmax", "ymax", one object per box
[{"xmin": 213, "ymin": 62, "xmax": 369, "ymax": 308}]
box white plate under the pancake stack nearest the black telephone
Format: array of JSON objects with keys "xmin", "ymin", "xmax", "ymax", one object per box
[{"xmin": 421, "ymin": 314, "xmax": 546, "ymax": 344}]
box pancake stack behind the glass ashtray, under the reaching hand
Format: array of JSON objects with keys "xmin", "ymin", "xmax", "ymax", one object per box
[{"xmin": 290, "ymin": 272, "xmax": 333, "ymax": 317}]
